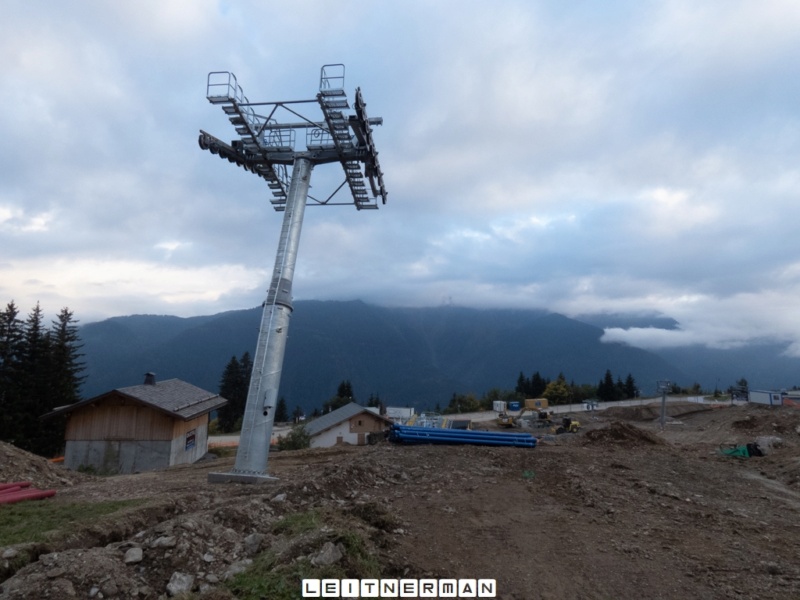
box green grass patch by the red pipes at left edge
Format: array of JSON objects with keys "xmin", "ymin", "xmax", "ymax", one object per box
[{"xmin": 0, "ymin": 500, "xmax": 145, "ymax": 547}]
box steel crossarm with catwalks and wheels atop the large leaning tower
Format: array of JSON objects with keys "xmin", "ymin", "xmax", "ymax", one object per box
[{"xmin": 198, "ymin": 64, "xmax": 387, "ymax": 211}]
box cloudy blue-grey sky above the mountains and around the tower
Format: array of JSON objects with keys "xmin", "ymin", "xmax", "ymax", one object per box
[{"xmin": 0, "ymin": 0, "xmax": 800, "ymax": 355}]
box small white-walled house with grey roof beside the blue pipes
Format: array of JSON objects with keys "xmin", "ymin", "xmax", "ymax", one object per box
[{"xmin": 305, "ymin": 402, "xmax": 392, "ymax": 448}]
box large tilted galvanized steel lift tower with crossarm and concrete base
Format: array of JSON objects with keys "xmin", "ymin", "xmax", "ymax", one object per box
[{"xmin": 198, "ymin": 64, "xmax": 387, "ymax": 483}]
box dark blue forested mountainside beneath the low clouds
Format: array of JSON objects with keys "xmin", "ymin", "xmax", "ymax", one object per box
[{"xmin": 81, "ymin": 301, "xmax": 691, "ymax": 410}]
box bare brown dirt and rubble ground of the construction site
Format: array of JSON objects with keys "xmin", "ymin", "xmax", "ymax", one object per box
[{"xmin": 0, "ymin": 405, "xmax": 800, "ymax": 600}]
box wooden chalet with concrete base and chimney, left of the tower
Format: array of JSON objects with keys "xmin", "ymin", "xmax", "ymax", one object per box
[{"xmin": 45, "ymin": 373, "xmax": 228, "ymax": 473}]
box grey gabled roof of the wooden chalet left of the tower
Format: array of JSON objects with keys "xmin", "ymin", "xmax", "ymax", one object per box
[{"xmin": 44, "ymin": 379, "xmax": 228, "ymax": 421}]
